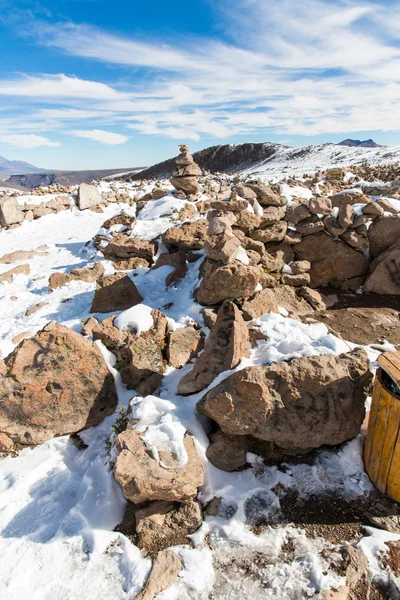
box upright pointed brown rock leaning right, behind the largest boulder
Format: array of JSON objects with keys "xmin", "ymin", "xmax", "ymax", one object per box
[{"xmin": 178, "ymin": 301, "xmax": 250, "ymax": 394}]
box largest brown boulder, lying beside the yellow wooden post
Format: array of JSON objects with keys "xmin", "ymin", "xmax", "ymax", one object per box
[{"xmin": 197, "ymin": 348, "xmax": 372, "ymax": 449}]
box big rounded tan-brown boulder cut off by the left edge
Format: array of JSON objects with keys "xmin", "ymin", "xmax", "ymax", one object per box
[{"xmin": 0, "ymin": 323, "xmax": 117, "ymax": 444}]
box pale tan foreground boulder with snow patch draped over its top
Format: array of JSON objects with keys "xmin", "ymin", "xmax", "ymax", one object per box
[{"xmin": 114, "ymin": 429, "xmax": 204, "ymax": 504}]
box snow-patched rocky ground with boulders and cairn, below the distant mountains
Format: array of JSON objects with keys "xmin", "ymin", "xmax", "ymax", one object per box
[{"xmin": 0, "ymin": 147, "xmax": 400, "ymax": 600}]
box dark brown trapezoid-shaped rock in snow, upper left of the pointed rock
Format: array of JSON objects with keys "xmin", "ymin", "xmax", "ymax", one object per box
[{"xmin": 90, "ymin": 273, "xmax": 143, "ymax": 313}]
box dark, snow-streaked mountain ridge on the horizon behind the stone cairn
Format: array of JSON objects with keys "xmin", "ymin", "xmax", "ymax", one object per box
[{"xmin": 125, "ymin": 142, "xmax": 400, "ymax": 180}]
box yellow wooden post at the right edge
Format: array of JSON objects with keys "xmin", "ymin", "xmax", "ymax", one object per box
[{"xmin": 364, "ymin": 352, "xmax": 400, "ymax": 502}]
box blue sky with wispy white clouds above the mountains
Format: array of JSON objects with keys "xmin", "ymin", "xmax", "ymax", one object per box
[{"xmin": 0, "ymin": 0, "xmax": 400, "ymax": 169}]
